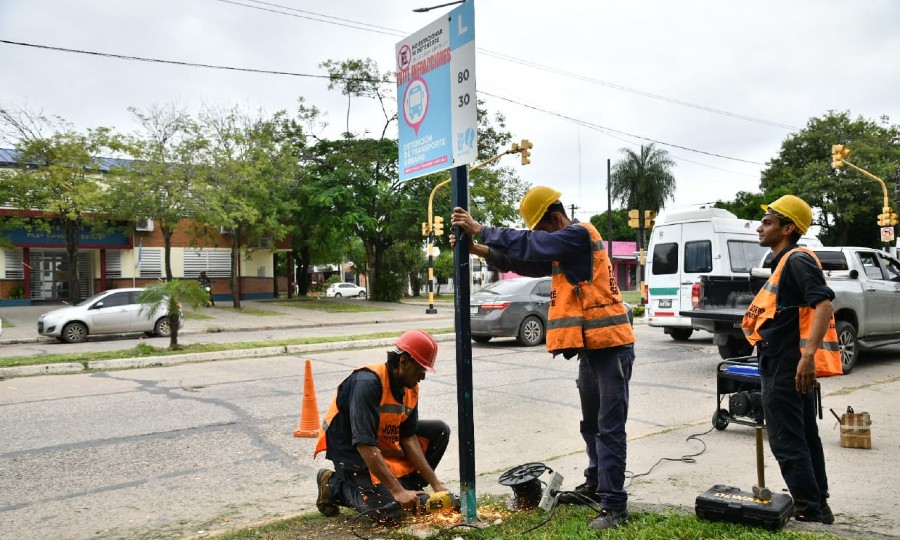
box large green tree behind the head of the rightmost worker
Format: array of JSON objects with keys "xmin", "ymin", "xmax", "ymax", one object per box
[{"xmin": 757, "ymin": 111, "xmax": 900, "ymax": 246}]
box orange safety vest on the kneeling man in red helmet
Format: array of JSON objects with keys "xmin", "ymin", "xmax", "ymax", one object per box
[{"xmin": 313, "ymin": 363, "xmax": 428, "ymax": 484}]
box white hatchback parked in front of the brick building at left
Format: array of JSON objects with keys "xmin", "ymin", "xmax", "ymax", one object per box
[{"xmin": 38, "ymin": 289, "xmax": 184, "ymax": 343}]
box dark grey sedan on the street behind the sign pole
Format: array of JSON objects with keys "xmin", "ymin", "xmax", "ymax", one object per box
[{"xmin": 470, "ymin": 277, "xmax": 550, "ymax": 347}]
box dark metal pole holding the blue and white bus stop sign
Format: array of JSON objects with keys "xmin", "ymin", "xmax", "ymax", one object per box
[{"xmin": 451, "ymin": 165, "xmax": 478, "ymax": 523}]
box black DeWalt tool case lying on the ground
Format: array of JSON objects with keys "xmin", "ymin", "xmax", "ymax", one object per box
[{"xmin": 694, "ymin": 484, "xmax": 794, "ymax": 531}]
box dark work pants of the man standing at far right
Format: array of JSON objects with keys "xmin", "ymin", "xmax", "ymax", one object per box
[{"xmin": 759, "ymin": 354, "xmax": 828, "ymax": 520}]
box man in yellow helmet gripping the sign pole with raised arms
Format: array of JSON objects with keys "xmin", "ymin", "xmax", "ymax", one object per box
[{"xmin": 451, "ymin": 186, "xmax": 634, "ymax": 530}]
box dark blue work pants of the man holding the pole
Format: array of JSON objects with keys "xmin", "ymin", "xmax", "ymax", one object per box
[{"xmin": 577, "ymin": 345, "xmax": 634, "ymax": 511}]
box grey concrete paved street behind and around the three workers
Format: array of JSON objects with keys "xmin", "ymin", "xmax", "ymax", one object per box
[{"xmin": 0, "ymin": 316, "xmax": 900, "ymax": 539}]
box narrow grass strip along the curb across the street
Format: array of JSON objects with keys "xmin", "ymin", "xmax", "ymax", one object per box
[{"xmin": 0, "ymin": 328, "xmax": 454, "ymax": 367}]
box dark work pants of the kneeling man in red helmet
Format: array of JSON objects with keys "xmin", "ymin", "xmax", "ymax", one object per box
[{"xmin": 331, "ymin": 420, "xmax": 450, "ymax": 522}]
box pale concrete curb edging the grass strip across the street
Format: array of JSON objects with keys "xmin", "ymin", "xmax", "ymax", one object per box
[{"xmin": 0, "ymin": 334, "xmax": 456, "ymax": 379}]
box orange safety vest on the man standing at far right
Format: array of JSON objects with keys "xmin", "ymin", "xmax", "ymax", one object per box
[{"xmin": 741, "ymin": 247, "xmax": 844, "ymax": 377}]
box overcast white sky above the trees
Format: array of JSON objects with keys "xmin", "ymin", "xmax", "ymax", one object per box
[{"xmin": 0, "ymin": 0, "xmax": 900, "ymax": 219}]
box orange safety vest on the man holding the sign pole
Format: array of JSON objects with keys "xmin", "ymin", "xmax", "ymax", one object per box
[{"xmin": 547, "ymin": 223, "xmax": 634, "ymax": 353}]
